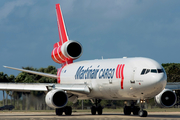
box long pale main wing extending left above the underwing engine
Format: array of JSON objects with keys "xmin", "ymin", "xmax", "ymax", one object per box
[{"xmin": 0, "ymin": 83, "xmax": 90, "ymax": 95}]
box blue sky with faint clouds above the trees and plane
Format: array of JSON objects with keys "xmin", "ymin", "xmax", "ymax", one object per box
[{"xmin": 0, "ymin": 0, "xmax": 180, "ymax": 100}]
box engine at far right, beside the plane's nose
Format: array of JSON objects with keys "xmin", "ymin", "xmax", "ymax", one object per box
[{"xmin": 154, "ymin": 89, "xmax": 177, "ymax": 107}]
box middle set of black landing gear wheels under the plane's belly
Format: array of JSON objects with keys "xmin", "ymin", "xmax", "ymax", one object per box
[{"xmin": 91, "ymin": 99, "xmax": 103, "ymax": 115}]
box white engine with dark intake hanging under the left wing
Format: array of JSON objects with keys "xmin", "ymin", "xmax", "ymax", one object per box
[{"xmin": 45, "ymin": 89, "xmax": 68, "ymax": 108}]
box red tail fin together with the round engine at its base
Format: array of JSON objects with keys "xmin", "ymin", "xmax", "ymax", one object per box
[{"xmin": 51, "ymin": 4, "xmax": 82, "ymax": 66}]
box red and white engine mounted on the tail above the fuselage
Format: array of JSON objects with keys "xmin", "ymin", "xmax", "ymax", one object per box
[{"xmin": 51, "ymin": 40, "xmax": 82, "ymax": 64}]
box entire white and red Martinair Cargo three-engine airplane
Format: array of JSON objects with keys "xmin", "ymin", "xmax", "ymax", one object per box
[{"xmin": 0, "ymin": 4, "xmax": 180, "ymax": 117}]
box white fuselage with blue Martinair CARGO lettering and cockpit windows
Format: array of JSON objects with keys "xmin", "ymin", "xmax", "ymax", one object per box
[{"xmin": 60, "ymin": 57, "xmax": 167, "ymax": 100}]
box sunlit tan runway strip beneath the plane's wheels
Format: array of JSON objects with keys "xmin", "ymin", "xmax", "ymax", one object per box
[{"xmin": 0, "ymin": 111, "xmax": 180, "ymax": 120}]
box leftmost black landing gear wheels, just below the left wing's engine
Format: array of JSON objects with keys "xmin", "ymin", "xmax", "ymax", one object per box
[{"xmin": 56, "ymin": 106, "xmax": 72, "ymax": 116}]
